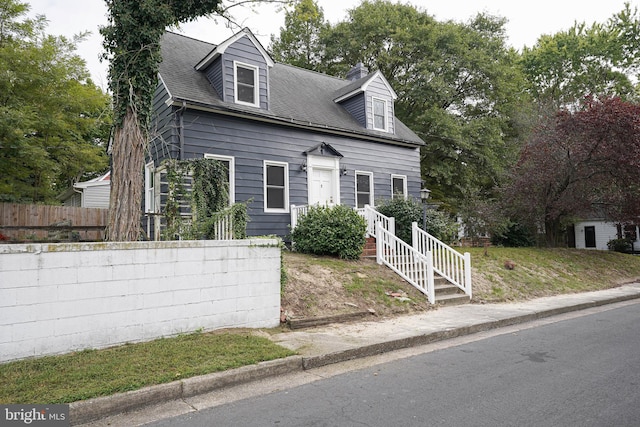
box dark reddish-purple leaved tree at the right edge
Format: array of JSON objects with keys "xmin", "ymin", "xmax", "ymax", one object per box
[{"xmin": 504, "ymin": 98, "xmax": 640, "ymax": 246}]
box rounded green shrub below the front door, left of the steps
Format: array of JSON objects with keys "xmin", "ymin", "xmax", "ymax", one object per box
[{"xmin": 291, "ymin": 205, "xmax": 367, "ymax": 259}]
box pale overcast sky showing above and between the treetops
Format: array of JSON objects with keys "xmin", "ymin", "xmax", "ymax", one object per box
[{"xmin": 28, "ymin": 0, "xmax": 640, "ymax": 90}]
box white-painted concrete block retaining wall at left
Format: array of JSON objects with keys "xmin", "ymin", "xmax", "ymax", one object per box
[{"xmin": 0, "ymin": 239, "xmax": 280, "ymax": 362}]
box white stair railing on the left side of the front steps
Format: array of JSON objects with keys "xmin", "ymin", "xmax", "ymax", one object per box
[{"xmin": 376, "ymin": 222, "xmax": 436, "ymax": 304}]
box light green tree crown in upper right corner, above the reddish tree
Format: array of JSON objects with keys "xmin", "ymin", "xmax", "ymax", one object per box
[{"xmin": 521, "ymin": 4, "xmax": 640, "ymax": 109}]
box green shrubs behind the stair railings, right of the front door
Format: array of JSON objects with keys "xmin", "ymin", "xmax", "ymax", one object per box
[{"xmin": 376, "ymin": 198, "xmax": 458, "ymax": 244}]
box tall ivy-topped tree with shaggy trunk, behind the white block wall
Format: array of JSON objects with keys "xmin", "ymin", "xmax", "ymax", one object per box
[{"xmin": 100, "ymin": 0, "xmax": 226, "ymax": 241}]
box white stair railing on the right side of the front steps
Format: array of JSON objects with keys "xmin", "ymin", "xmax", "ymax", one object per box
[{"xmin": 411, "ymin": 222, "xmax": 471, "ymax": 297}]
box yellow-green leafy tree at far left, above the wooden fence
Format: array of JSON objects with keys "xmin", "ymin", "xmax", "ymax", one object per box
[{"xmin": 0, "ymin": 0, "xmax": 110, "ymax": 203}]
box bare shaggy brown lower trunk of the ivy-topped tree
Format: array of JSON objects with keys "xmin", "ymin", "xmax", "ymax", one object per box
[{"xmin": 107, "ymin": 109, "xmax": 147, "ymax": 242}]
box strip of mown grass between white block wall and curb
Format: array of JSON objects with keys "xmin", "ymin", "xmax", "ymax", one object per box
[{"xmin": 0, "ymin": 332, "xmax": 294, "ymax": 404}]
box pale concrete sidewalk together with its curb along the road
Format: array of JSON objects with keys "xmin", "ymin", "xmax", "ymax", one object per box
[{"xmin": 70, "ymin": 283, "xmax": 640, "ymax": 425}]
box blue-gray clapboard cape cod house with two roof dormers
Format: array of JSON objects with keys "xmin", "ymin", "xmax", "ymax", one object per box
[{"xmin": 144, "ymin": 29, "xmax": 424, "ymax": 239}]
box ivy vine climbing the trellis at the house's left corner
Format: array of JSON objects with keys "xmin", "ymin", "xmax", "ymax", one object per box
[{"xmin": 163, "ymin": 158, "xmax": 249, "ymax": 240}]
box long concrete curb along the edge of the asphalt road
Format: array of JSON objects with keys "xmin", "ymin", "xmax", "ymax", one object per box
[{"xmin": 69, "ymin": 293, "xmax": 640, "ymax": 425}]
